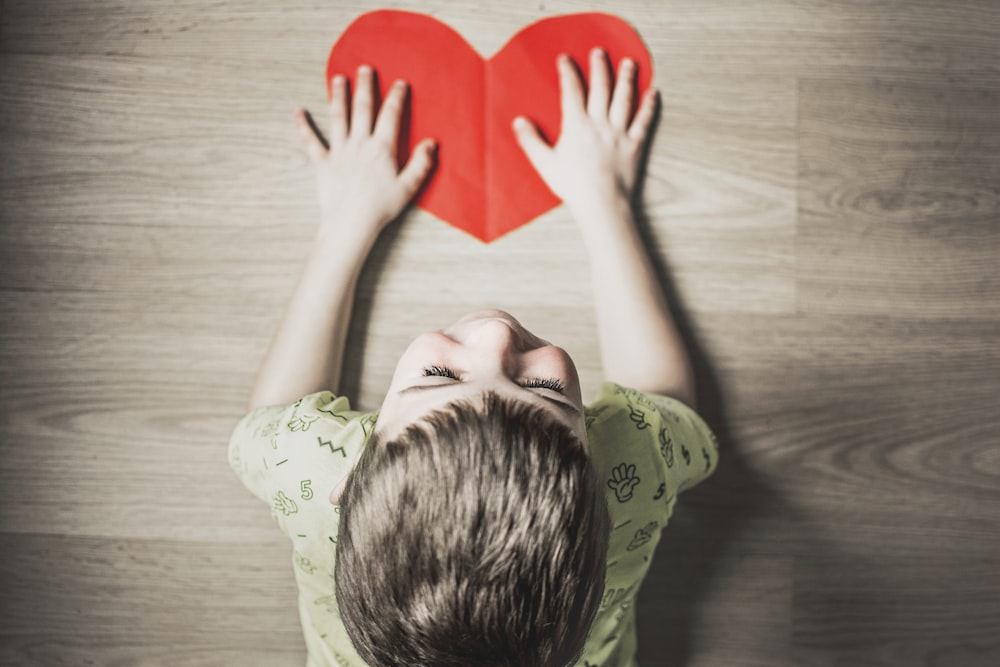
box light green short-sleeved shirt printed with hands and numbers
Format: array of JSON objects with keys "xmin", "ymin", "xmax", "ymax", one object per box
[{"xmin": 229, "ymin": 383, "xmax": 718, "ymax": 667}]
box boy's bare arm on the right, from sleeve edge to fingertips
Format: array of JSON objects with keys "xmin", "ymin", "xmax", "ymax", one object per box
[{"xmin": 514, "ymin": 49, "xmax": 695, "ymax": 406}]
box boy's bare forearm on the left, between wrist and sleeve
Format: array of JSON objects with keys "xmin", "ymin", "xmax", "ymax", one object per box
[{"xmin": 250, "ymin": 237, "xmax": 368, "ymax": 409}]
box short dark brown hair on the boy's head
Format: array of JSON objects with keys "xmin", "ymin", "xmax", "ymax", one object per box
[{"xmin": 335, "ymin": 393, "xmax": 610, "ymax": 667}]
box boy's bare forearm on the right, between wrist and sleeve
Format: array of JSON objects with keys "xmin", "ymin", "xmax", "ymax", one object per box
[{"xmin": 574, "ymin": 197, "xmax": 695, "ymax": 406}]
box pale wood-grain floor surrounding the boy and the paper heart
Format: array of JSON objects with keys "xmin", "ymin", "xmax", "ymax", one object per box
[{"xmin": 0, "ymin": 0, "xmax": 1000, "ymax": 667}]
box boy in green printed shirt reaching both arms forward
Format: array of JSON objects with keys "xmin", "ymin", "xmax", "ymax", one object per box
[{"xmin": 230, "ymin": 49, "xmax": 717, "ymax": 666}]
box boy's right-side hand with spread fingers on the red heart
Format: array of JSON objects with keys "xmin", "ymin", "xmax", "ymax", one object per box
[{"xmin": 514, "ymin": 48, "xmax": 656, "ymax": 219}]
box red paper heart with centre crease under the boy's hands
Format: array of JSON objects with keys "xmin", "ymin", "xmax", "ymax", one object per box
[{"xmin": 326, "ymin": 10, "xmax": 653, "ymax": 243}]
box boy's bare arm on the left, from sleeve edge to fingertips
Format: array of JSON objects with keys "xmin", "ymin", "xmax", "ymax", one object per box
[{"xmin": 250, "ymin": 67, "xmax": 434, "ymax": 409}]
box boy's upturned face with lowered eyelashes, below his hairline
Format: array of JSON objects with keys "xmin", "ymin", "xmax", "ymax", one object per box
[{"xmin": 376, "ymin": 310, "xmax": 587, "ymax": 444}]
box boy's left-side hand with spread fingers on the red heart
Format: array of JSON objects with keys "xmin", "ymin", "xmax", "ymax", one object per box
[{"xmin": 295, "ymin": 65, "xmax": 435, "ymax": 244}]
